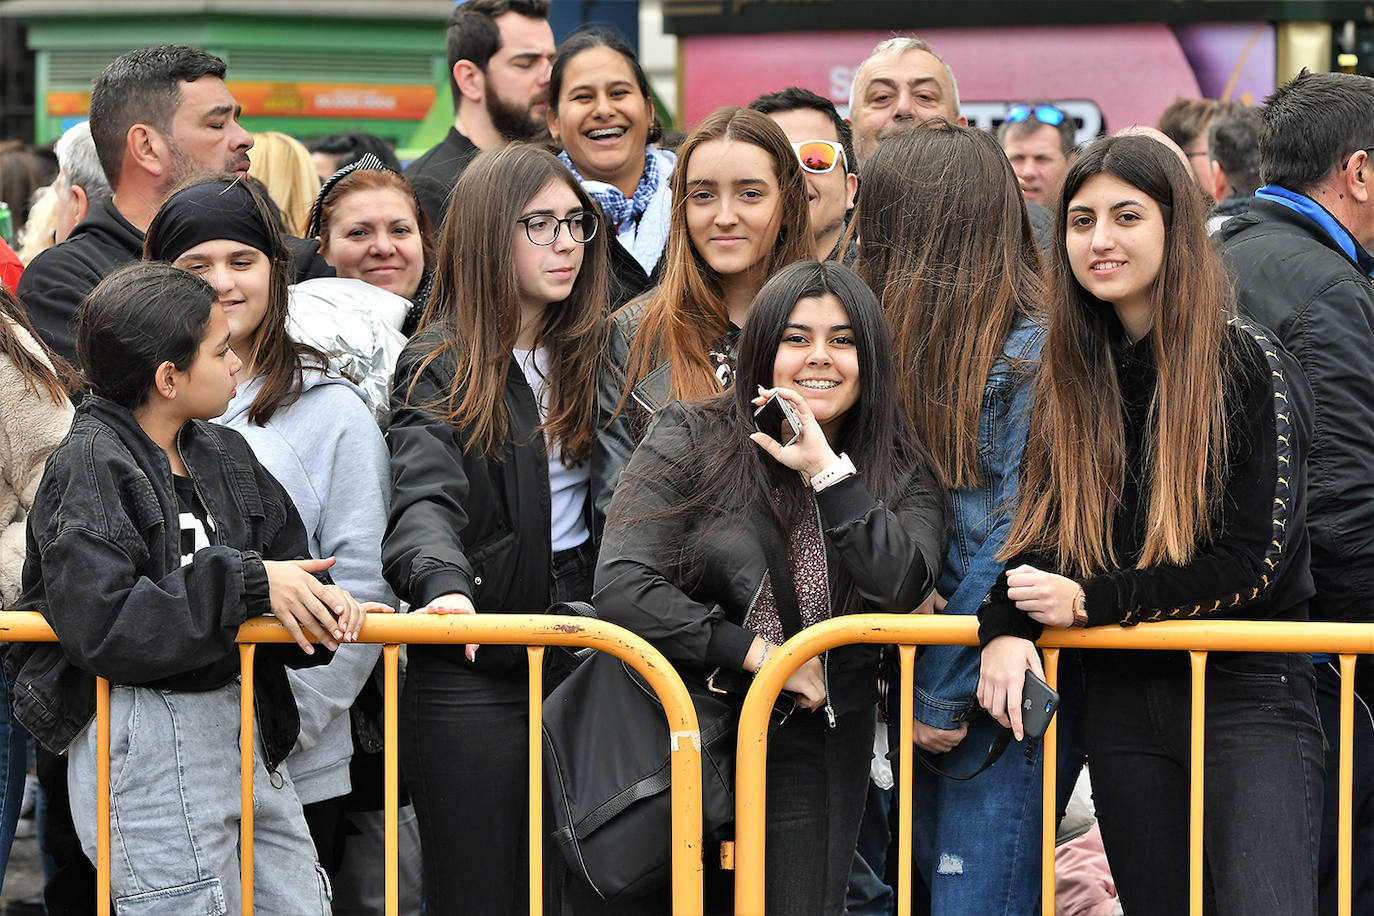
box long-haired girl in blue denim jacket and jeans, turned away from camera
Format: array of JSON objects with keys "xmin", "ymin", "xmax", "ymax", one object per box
[{"xmin": 859, "ymin": 122, "xmax": 1044, "ymax": 916}]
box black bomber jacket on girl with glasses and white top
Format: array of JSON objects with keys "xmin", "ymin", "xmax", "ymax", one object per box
[{"xmin": 382, "ymin": 328, "xmax": 610, "ymax": 670}]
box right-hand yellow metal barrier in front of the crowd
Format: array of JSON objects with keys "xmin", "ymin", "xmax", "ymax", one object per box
[{"xmin": 735, "ymin": 614, "xmax": 1374, "ymax": 916}]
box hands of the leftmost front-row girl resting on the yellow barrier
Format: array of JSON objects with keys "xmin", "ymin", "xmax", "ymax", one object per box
[{"xmin": 262, "ymin": 556, "xmax": 373, "ymax": 655}]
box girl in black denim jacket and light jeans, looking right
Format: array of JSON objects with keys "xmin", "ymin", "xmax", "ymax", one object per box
[{"xmin": 7, "ymin": 264, "xmax": 376, "ymax": 916}]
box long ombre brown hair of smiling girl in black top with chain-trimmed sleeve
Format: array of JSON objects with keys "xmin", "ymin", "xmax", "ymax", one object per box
[{"xmin": 1002, "ymin": 136, "xmax": 1235, "ymax": 575}]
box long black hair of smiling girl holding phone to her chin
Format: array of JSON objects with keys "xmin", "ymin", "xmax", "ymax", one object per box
[{"xmin": 622, "ymin": 261, "xmax": 933, "ymax": 596}]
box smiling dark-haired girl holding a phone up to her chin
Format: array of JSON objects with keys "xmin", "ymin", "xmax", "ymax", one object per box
[{"xmin": 595, "ymin": 261, "xmax": 944, "ymax": 916}]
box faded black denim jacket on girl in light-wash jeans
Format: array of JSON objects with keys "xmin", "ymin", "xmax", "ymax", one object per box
[{"xmin": 5, "ymin": 396, "xmax": 331, "ymax": 766}]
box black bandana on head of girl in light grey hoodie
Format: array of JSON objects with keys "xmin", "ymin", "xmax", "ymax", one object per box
[{"xmin": 147, "ymin": 179, "xmax": 272, "ymax": 261}]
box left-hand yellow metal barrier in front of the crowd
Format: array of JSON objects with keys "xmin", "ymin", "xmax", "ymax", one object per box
[{"xmin": 0, "ymin": 611, "xmax": 702, "ymax": 916}]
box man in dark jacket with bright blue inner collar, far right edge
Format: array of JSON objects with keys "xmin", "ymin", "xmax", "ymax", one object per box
[{"xmin": 1219, "ymin": 70, "xmax": 1374, "ymax": 913}]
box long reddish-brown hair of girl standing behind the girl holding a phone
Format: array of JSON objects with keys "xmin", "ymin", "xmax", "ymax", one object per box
[{"xmin": 621, "ymin": 107, "xmax": 811, "ymax": 405}]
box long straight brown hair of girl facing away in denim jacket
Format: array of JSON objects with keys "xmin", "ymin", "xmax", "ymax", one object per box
[{"xmin": 857, "ymin": 119, "xmax": 1043, "ymax": 489}]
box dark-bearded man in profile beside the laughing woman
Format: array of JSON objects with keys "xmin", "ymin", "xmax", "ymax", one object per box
[{"xmin": 405, "ymin": 0, "xmax": 554, "ymax": 227}]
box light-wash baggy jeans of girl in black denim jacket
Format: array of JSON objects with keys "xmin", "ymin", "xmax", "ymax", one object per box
[{"xmin": 67, "ymin": 680, "xmax": 330, "ymax": 916}]
